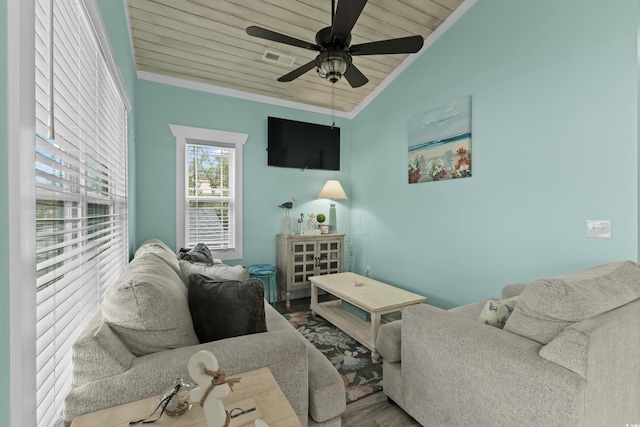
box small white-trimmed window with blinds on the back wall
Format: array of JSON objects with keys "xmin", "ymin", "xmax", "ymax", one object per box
[{"xmin": 169, "ymin": 124, "xmax": 249, "ymax": 260}]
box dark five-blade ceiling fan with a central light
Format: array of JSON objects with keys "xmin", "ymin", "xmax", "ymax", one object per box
[{"xmin": 247, "ymin": 0, "xmax": 424, "ymax": 88}]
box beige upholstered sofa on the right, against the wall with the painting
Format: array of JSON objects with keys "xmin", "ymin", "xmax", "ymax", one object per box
[{"xmin": 377, "ymin": 261, "xmax": 640, "ymax": 427}]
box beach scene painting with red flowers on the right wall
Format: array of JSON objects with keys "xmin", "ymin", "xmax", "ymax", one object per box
[{"xmin": 408, "ymin": 96, "xmax": 471, "ymax": 184}]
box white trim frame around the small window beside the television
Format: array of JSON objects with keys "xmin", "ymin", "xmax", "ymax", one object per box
[{"xmin": 169, "ymin": 124, "xmax": 249, "ymax": 260}]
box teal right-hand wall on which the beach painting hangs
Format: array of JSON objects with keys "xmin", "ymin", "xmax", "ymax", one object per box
[{"xmin": 351, "ymin": 0, "xmax": 638, "ymax": 307}]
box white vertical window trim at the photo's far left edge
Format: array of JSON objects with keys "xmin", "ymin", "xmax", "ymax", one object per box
[{"xmin": 3, "ymin": 1, "xmax": 36, "ymax": 427}]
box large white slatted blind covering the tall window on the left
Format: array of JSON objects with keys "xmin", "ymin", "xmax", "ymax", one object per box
[{"xmin": 35, "ymin": 0, "xmax": 128, "ymax": 426}]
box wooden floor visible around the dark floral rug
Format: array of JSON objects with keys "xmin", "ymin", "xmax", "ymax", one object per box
[{"xmin": 277, "ymin": 295, "xmax": 420, "ymax": 427}]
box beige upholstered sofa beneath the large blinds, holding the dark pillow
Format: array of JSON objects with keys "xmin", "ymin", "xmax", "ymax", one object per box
[{"xmin": 64, "ymin": 240, "xmax": 346, "ymax": 426}]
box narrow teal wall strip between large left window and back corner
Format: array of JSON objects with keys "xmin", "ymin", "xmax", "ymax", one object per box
[{"xmin": 98, "ymin": 0, "xmax": 137, "ymax": 256}]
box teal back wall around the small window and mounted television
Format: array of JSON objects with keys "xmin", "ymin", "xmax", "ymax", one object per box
[{"xmin": 135, "ymin": 80, "xmax": 351, "ymax": 265}]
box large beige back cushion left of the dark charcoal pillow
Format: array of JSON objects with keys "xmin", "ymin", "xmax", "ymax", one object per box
[{"xmin": 102, "ymin": 253, "xmax": 198, "ymax": 356}]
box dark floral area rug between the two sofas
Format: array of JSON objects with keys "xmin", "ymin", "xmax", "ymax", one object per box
[{"xmin": 284, "ymin": 311, "xmax": 382, "ymax": 404}]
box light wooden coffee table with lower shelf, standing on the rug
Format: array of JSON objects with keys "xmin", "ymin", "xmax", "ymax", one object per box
[{"xmin": 309, "ymin": 273, "xmax": 427, "ymax": 361}]
